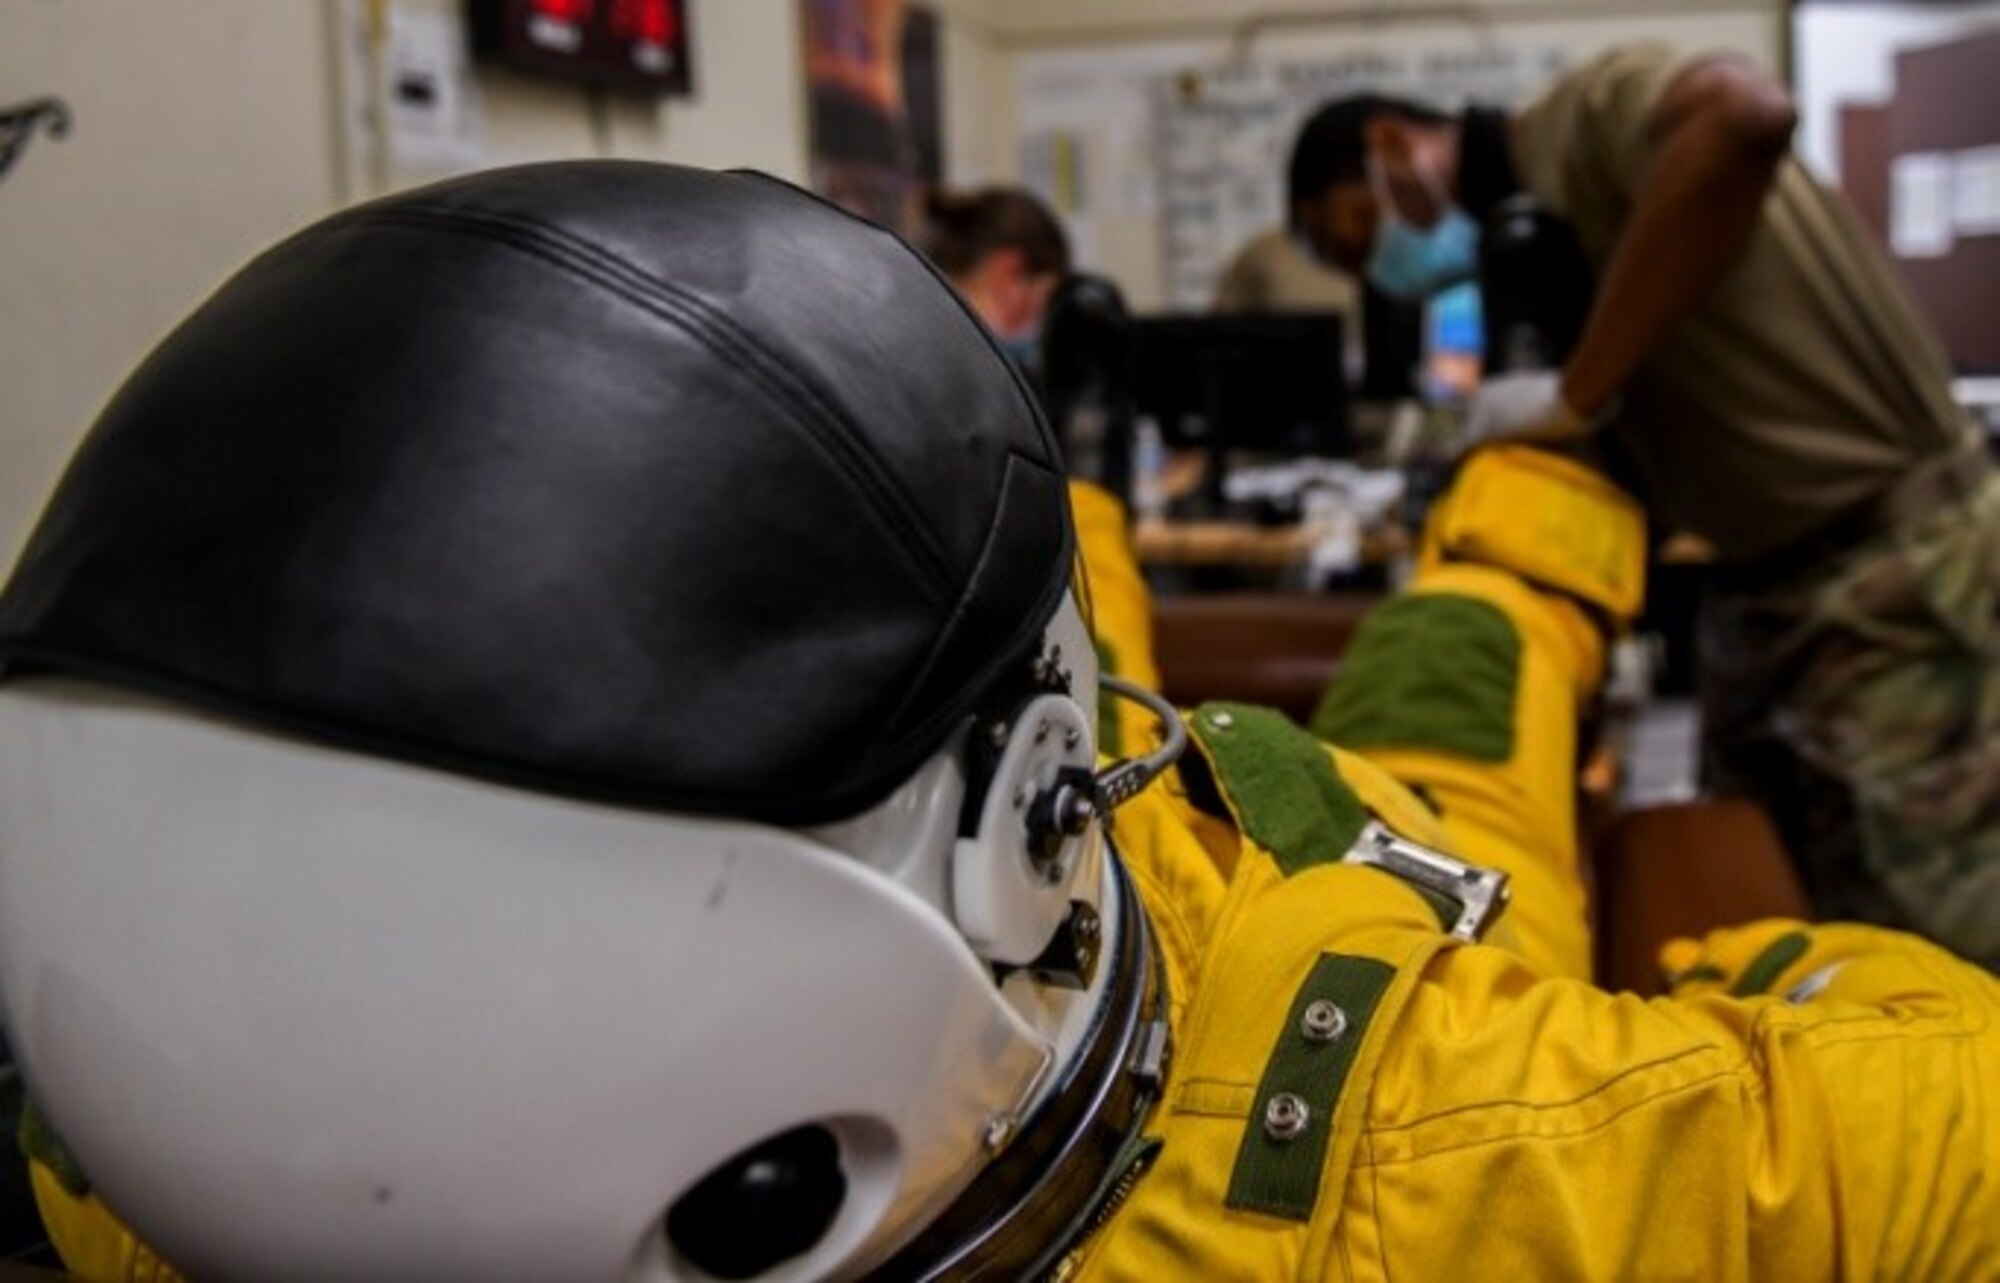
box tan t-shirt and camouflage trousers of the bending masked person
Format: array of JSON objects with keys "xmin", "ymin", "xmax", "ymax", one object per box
[{"xmin": 1508, "ymin": 44, "xmax": 2000, "ymax": 965}]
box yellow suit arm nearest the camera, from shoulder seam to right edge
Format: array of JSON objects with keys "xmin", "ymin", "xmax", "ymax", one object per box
[{"xmin": 1338, "ymin": 923, "xmax": 2000, "ymax": 1281}]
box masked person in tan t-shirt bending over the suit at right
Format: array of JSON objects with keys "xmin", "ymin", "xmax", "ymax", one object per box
[{"xmin": 1292, "ymin": 44, "xmax": 2000, "ymax": 965}]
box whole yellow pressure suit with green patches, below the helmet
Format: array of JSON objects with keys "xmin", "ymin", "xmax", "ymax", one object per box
[{"xmin": 1056, "ymin": 450, "xmax": 2000, "ymax": 1283}]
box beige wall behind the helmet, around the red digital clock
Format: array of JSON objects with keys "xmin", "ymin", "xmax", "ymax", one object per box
[{"xmin": 0, "ymin": 0, "xmax": 1012, "ymax": 559}]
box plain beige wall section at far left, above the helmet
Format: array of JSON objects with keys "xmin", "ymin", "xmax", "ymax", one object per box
[{"xmin": 0, "ymin": 0, "xmax": 334, "ymax": 564}]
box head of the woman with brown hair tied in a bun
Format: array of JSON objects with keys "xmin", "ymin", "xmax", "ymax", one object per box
[{"xmin": 918, "ymin": 186, "xmax": 1070, "ymax": 370}]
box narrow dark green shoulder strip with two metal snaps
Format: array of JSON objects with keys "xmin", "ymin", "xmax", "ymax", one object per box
[{"xmin": 1226, "ymin": 953, "xmax": 1396, "ymax": 1221}]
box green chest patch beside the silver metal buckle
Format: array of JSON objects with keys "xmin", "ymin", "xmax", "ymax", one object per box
[{"xmin": 1190, "ymin": 703, "xmax": 1368, "ymax": 877}]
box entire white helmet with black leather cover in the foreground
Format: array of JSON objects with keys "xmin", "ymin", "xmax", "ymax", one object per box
[{"xmin": 0, "ymin": 162, "xmax": 1170, "ymax": 1279}]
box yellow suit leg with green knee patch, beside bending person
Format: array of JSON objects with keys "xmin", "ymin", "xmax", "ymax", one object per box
[{"xmin": 1312, "ymin": 448, "xmax": 1644, "ymax": 979}]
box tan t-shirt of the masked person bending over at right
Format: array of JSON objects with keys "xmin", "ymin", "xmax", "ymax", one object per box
[{"xmin": 1514, "ymin": 44, "xmax": 1970, "ymax": 560}]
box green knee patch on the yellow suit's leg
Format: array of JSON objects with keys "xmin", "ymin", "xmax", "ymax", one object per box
[{"xmin": 1312, "ymin": 594, "xmax": 1520, "ymax": 761}]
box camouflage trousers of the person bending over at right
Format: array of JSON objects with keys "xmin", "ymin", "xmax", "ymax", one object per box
[{"xmin": 1702, "ymin": 478, "xmax": 2000, "ymax": 969}]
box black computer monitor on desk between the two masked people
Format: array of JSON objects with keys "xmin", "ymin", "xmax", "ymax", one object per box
[{"xmin": 1134, "ymin": 312, "xmax": 1352, "ymax": 456}]
